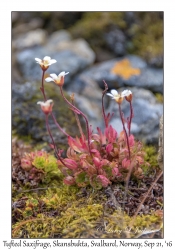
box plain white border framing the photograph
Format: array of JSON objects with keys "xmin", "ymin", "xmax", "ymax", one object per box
[{"xmin": 0, "ymin": 0, "xmax": 175, "ymax": 249}]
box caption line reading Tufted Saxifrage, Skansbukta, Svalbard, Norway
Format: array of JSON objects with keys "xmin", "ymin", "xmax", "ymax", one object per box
[{"xmin": 2, "ymin": 239, "xmax": 173, "ymax": 249}]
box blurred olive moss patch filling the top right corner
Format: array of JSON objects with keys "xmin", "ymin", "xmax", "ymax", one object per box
[{"xmin": 128, "ymin": 12, "xmax": 163, "ymax": 61}]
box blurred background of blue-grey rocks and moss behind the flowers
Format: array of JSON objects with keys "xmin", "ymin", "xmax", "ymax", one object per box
[{"xmin": 12, "ymin": 12, "xmax": 163, "ymax": 148}]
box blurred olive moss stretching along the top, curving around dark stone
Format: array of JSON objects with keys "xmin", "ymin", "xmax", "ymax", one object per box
[{"xmin": 69, "ymin": 12, "xmax": 163, "ymax": 64}]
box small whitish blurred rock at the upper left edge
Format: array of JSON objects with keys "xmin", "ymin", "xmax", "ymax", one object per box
[{"xmin": 13, "ymin": 29, "xmax": 47, "ymax": 50}]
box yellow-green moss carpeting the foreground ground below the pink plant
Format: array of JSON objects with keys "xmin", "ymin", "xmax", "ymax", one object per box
[{"xmin": 12, "ymin": 170, "xmax": 162, "ymax": 238}]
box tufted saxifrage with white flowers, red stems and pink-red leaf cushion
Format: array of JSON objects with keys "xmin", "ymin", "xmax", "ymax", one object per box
[{"xmin": 35, "ymin": 57, "xmax": 149, "ymax": 188}]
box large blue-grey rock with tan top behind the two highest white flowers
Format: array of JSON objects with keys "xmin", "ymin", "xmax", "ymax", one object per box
[{"xmin": 16, "ymin": 32, "xmax": 95, "ymax": 82}]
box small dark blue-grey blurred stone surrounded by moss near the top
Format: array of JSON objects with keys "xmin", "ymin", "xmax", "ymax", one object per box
[{"xmin": 104, "ymin": 29, "xmax": 126, "ymax": 56}]
